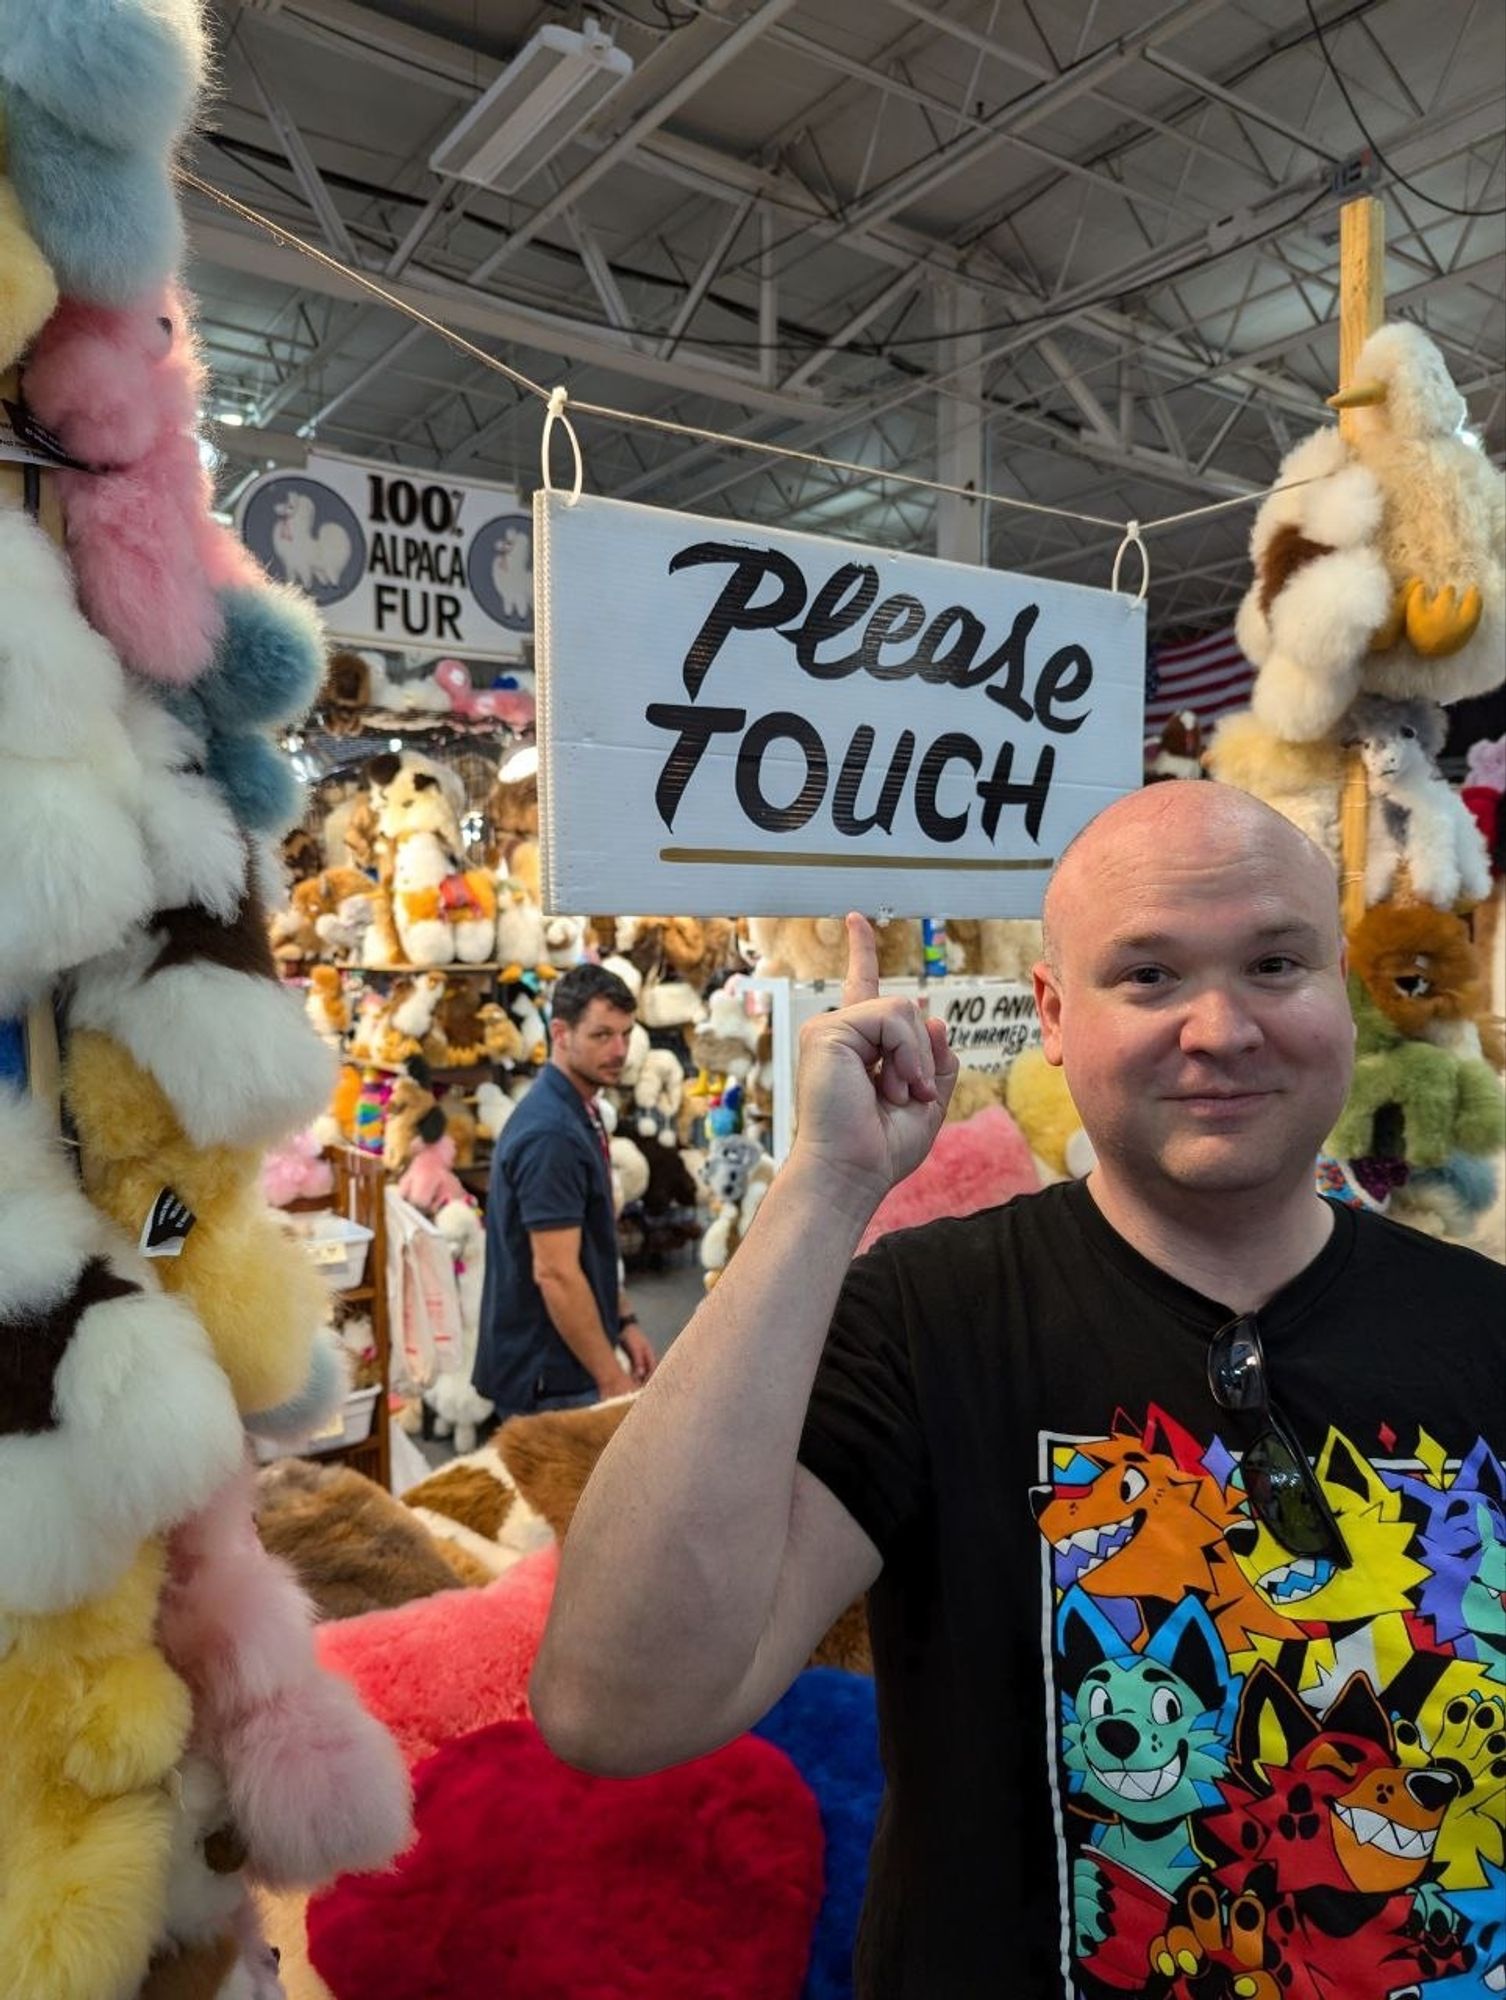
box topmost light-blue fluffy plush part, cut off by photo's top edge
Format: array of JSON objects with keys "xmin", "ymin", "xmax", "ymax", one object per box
[{"xmin": 0, "ymin": 0, "xmax": 206, "ymax": 154}]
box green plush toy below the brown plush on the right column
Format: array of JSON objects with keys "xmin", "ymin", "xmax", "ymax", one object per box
[{"xmin": 1326, "ymin": 972, "xmax": 1506, "ymax": 1168}]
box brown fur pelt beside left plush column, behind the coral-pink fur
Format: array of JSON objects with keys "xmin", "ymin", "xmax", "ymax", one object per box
[{"xmin": 256, "ymin": 1458, "xmax": 462, "ymax": 1618}]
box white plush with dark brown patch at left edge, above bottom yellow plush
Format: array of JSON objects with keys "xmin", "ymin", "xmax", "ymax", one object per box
[{"xmin": 0, "ymin": 1090, "xmax": 244, "ymax": 1614}]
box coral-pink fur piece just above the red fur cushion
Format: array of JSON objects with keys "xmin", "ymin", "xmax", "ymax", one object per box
[{"xmin": 316, "ymin": 1544, "xmax": 560, "ymax": 1764}]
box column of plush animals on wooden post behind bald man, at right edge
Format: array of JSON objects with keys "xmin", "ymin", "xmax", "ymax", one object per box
[{"xmin": 1206, "ymin": 324, "xmax": 1506, "ymax": 1254}]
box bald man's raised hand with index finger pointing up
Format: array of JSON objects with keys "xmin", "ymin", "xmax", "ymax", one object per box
[{"xmin": 794, "ymin": 916, "xmax": 958, "ymax": 1210}]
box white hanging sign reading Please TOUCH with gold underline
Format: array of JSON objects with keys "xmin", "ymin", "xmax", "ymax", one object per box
[{"xmin": 534, "ymin": 492, "xmax": 1146, "ymax": 916}]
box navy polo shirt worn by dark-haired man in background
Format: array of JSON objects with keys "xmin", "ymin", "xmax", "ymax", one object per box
[{"xmin": 472, "ymin": 1062, "xmax": 618, "ymax": 1416}]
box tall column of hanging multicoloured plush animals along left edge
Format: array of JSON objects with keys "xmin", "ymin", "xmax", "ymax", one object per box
[{"xmin": 0, "ymin": 11, "xmax": 408, "ymax": 2000}]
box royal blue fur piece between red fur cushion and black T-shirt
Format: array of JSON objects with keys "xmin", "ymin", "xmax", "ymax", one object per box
[{"xmin": 754, "ymin": 1666, "xmax": 884, "ymax": 2000}]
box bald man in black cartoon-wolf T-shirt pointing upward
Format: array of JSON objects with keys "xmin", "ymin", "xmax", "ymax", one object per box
[{"xmin": 532, "ymin": 784, "xmax": 1506, "ymax": 2000}]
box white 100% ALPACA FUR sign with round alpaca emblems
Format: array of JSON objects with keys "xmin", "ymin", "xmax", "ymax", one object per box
[{"xmin": 236, "ymin": 452, "xmax": 534, "ymax": 660}]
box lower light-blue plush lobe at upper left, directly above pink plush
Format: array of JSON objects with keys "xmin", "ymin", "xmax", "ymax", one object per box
[{"xmin": 0, "ymin": 88, "xmax": 184, "ymax": 306}]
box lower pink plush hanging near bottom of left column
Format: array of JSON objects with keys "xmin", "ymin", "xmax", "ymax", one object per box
[{"xmin": 160, "ymin": 1468, "xmax": 412, "ymax": 1888}]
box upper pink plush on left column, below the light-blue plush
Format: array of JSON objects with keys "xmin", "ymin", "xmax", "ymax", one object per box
[{"xmin": 24, "ymin": 286, "xmax": 262, "ymax": 686}]
